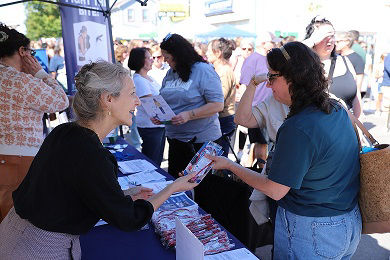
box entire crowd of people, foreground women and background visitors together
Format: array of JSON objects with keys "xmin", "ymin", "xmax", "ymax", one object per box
[{"xmin": 0, "ymin": 17, "xmax": 390, "ymax": 259}]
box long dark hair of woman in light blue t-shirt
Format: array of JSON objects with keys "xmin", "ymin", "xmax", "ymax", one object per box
[{"xmin": 160, "ymin": 34, "xmax": 207, "ymax": 82}]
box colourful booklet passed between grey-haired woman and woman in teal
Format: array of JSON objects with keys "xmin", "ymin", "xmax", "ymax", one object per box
[{"xmin": 184, "ymin": 142, "xmax": 223, "ymax": 183}]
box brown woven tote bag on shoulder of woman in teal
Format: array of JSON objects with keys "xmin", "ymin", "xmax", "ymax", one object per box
[{"xmin": 347, "ymin": 111, "xmax": 390, "ymax": 234}]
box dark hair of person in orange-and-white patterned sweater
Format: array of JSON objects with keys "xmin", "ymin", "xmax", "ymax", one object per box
[{"xmin": 0, "ymin": 23, "xmax": 30, "ymax": 58}]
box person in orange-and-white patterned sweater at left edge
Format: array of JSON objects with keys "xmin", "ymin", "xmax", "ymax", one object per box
[{"xmin": 0, "ymin": 23, "xmax": 69, "ymax": 222}]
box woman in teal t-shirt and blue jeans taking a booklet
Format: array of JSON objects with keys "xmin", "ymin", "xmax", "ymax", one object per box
[{"xmin": 209, "ymin": 42, "xmax": 361, "ymax": 259}]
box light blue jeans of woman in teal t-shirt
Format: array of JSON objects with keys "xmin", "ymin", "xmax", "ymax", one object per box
[{"xmin": 274, "ymin": 205, "xmax": 362, "ymax": 260}]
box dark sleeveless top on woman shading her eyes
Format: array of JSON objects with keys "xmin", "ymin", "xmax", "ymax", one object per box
[{"xmin": 329, "ymin": 56, "xmax": 357, "ymax": 108}]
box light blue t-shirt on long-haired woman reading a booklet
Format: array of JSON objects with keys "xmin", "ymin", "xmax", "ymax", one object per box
[{"xmin": 160, "ymin": 62, "xmax": 224, "ymax": 143}]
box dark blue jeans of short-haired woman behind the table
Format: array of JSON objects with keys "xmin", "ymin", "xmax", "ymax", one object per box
[{"xmin": 138, "ymin": 127, "xmax": 165, "ymax": 167}]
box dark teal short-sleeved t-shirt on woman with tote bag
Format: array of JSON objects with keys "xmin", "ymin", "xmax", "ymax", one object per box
[{"xmin": 269, "ymin": 102, "xmax": 360, "ymax": 217}]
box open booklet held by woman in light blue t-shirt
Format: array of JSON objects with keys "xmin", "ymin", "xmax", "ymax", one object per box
[{"xmin": 141, "ymin": 95, "xmax": 175, "ymax": 124}]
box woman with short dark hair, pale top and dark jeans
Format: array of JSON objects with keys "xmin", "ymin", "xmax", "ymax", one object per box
[{"xmin": 128, "ymin": 48, "xmax": 165, "ymax": 166}]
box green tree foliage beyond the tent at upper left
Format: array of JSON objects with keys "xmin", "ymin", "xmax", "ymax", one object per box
[{"xmin": 26, "ymin": 2, "xmax": 61, "ymax": 40}]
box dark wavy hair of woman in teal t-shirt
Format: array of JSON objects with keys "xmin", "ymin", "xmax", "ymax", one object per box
[{"xmin": 267, "ymin": 42, "xmax": 333, "ymax": 117}]
